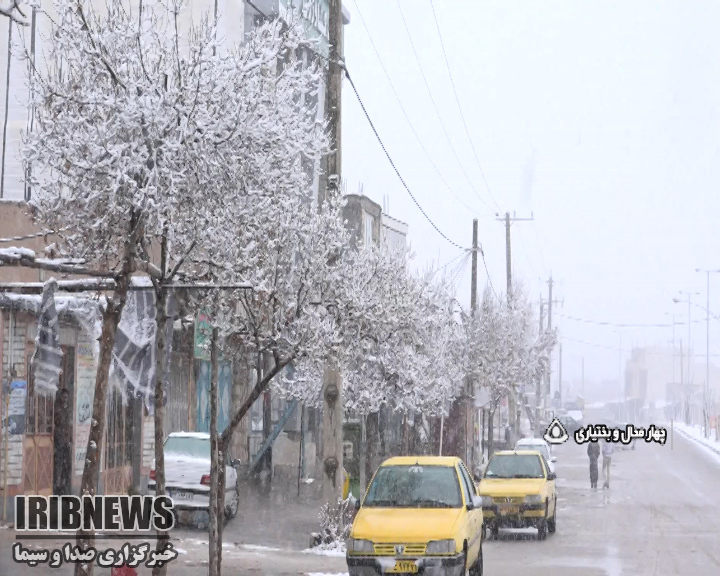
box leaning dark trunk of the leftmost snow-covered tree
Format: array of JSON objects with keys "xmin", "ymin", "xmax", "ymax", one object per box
[{"xmin": 75, "ymin": 294, "xmax": 127, "ymax": 576}]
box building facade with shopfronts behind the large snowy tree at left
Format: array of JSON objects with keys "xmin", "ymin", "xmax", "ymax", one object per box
[{"xmin": 0, "ymin": 0, "xmax": 354, "ymax": 510}]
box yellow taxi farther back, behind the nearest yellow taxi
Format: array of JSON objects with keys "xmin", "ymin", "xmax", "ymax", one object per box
[{"xmin": 480, "ymin": 450, "xmax": 557, "ymax": 540}]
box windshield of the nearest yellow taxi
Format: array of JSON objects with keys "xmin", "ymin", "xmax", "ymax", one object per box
[{"xmin": 363, "ymin": 465, "xmax": 462, "ymax": 508}]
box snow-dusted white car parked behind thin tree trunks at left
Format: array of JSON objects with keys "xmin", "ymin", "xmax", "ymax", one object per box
[{"xmin": 148, "ymin": 432, "xmax": 240, "ymax": 524}]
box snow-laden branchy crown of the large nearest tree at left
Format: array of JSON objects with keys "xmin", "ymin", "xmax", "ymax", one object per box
[{"xmin": 24, "ymin": 0, "xmax": 326, "ymax": 272}]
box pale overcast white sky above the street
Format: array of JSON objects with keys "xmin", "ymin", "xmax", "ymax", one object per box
[{"xmin": 342, "ymin": 0, "xmax": 720, "ymax": 394}]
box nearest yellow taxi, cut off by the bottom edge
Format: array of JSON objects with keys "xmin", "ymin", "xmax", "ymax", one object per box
[{"xmin": 347, "ymin": 456, "xmax": 483, "ymax": 576}]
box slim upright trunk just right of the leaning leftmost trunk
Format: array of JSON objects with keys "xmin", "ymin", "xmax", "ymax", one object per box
[{"xmin": 152, "ymin": 286, "xmax": 170, "ymax": 576}]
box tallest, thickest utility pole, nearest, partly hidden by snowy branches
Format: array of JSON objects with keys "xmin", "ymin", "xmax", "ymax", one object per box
[{"xmin": 322, "ymin": 0, "xmax": 344, "ymax": 525}]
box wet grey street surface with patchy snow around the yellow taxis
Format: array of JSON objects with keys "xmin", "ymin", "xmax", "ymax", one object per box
[{"xmin": 0, "ymin": 433, "xmax": 720, "ymax": 576}]
